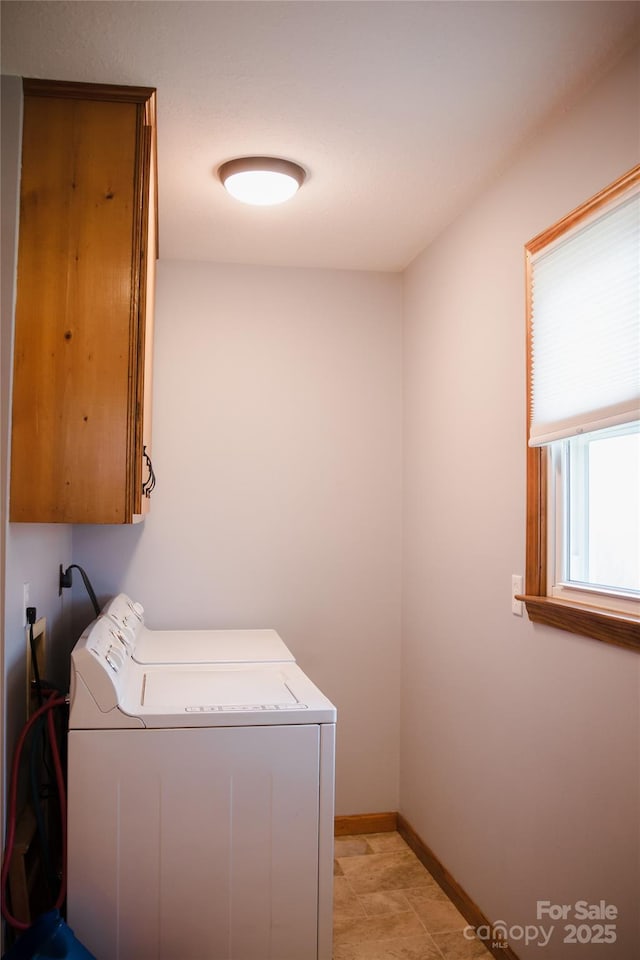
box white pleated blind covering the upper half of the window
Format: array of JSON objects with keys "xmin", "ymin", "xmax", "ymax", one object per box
[{"xmin": 529, "ymin": 190, "xmax": 640, "ymax": 446}]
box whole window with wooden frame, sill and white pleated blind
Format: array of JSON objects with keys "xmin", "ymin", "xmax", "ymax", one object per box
[{"xmin": 525, "ymin": 165, "xmax": 640, "ymax": 650}]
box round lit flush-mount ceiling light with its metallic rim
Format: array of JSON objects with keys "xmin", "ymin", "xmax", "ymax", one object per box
[{"xmin": 218, "ymin": 157, "xmax": 305, "ymax": 207}]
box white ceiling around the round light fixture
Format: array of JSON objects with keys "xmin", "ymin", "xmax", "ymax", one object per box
[{"xmin": 0, "ymin": 0, "xmax": 640, "ymax": 270}]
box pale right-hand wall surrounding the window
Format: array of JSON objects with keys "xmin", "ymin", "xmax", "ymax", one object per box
[{"xmin": 400, "ymin": 43, "xmax": 640, "ymax": 960}]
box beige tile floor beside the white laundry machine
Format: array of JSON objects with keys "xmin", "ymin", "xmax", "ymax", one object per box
[{"xmin": 333, "ymin": 833, "xmax": 491, "ymax": 960}]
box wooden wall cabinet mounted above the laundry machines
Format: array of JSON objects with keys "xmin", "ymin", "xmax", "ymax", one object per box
[{"xmin": 10, "ymin": 80, "xmax": 157, "ymax": 523}]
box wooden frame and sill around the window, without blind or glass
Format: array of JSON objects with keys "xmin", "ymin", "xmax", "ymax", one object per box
[{"xmin": 518, "ymin": 164, "xmax": 640, "ymax": 652}]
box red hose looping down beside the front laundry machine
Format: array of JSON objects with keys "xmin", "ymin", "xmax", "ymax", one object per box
[{"xmin": 2, "ymin": 695, "xmax": 67, "ymax": 930}]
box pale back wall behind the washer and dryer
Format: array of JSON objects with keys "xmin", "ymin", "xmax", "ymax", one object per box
[{"xmin": 74, "ymin": 262, "xmax": 402, "ymax": 814}]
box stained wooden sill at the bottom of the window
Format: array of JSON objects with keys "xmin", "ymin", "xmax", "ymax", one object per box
[{"xmin": 516, "ymin": 594, "xmax": 640, "ymax": 652}]
